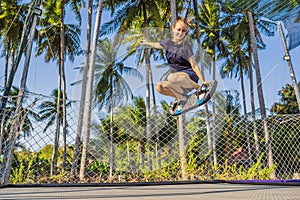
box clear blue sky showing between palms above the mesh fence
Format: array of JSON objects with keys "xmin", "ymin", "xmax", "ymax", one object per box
[{"xmin": 0, "ymin": 3, "xmax": 300, "ymax": 114}]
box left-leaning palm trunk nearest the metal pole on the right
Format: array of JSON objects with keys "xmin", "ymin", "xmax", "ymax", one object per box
[{"xmin": 248, "ymin": 11, "xmax": 276, "ymax": 178}]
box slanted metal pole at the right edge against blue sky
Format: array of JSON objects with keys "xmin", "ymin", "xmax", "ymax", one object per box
[{"xmin": 278, "ymin": 22, "xmax": 300, "ymax": 111}]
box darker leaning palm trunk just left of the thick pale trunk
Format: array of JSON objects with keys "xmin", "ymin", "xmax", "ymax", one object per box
[{"xmin": 71, "ymin": 0, "xmax": 93, "ymax": 176}]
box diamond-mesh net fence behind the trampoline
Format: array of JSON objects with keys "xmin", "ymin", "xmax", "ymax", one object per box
[{"xmin": 0, "ymin": 90, "xmax": 300, "ymax": 184}]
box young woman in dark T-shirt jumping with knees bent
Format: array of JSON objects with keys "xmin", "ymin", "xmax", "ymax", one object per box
[{"xmin": 143, "ymin": 19, "xmax": 205, "ymax": 114}]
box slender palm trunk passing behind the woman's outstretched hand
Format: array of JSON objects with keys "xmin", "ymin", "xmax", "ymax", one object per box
[{"xmin": 143, "ymin": 0, "xmax": 152, "ymax": 171}]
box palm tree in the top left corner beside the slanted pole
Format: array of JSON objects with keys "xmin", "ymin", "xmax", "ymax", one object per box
[{"xmin": 0, "ymin": 1, "xmax": 30, "ymax": 127}]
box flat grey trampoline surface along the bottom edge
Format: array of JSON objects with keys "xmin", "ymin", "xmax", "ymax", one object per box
[{"xmin": 0, "ymin": 183, "xmax": 300, "ymax": 200}]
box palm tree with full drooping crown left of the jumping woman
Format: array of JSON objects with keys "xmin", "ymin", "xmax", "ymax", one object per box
[{"xmin": 95, "ymin": 39, "xmax": 142, "ymax": 181}]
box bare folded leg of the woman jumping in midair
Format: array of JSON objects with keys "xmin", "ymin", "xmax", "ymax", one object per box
[{"xmin": 156, "ymin": 72, "xmax": 199, "ymax": 99}]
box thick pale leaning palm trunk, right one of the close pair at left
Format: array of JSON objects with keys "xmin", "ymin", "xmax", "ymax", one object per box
[{"xmin": 79, "ymin": 0, "xmax": 103, "ymax": 180}]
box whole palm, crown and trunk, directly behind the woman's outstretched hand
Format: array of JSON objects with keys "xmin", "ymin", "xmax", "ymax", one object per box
[{"xmin": 101, "ymin": 0, "xmax": 163, "ymax": 171}]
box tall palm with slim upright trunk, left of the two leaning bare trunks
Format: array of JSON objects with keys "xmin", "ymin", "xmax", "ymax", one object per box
[{"xmin": 37, "ymin": 0, "xmax": 83, "ymax": 173}]
